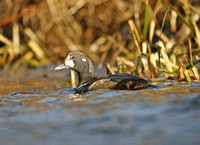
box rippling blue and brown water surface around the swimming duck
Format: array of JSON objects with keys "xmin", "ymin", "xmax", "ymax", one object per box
[{"xmin": 0, "ymin": 67, "xmax": 200, "ymax": 145}]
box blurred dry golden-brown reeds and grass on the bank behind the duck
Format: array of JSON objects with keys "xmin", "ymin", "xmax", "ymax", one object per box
[{"xmin": 0, "ymin": 0, "xmax": 200, "ymax": 82}]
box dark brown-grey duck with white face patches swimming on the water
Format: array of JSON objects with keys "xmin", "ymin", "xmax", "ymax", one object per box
[{"xmin": 55, "ymin": 51, "xmax": 149, "ymax": 93}]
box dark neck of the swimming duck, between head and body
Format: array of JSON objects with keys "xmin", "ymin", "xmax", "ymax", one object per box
[{"xmin": 78, "ymin": 72, "xmax": 97, "ymax": 86}]
